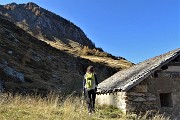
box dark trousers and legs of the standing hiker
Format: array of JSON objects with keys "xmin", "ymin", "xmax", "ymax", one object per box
[{"xmin": 85, "ymin": 89, "xmax": 96, "ymax": 113}]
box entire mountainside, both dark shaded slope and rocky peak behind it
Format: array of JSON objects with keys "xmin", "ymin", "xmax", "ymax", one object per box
[{"xmin": 0, "ymin": 2, "xmax": 133, "ymax": 94}]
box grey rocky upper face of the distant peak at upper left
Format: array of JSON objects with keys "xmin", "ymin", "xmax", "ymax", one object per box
[{"xmin": 0, "ymin": 2, "xmax": 95, "ymax": 48}]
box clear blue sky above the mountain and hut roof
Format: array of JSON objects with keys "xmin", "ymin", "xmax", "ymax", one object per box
[{"xmin": 0, "ymin": 0, "xmax": 180, "ymax": 63}]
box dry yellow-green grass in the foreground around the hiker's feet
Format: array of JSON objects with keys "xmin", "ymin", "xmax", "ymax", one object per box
[{"xmin": 0, "ymin": 94, "xmax": 167, "ymax": 120}]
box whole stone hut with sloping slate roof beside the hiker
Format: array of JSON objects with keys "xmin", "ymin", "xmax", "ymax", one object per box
[{"xmin": 97, "ymin": 48, "xmax": 180, "ymax": 115}]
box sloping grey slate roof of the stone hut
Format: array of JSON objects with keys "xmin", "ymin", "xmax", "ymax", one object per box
[{"xmin": 97, "ymin": 48, "xmax": 180, "ymax": 94}]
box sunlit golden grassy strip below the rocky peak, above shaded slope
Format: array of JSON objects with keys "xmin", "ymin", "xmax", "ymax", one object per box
[{"xmin": 40, "ymin": 40, "xmax": 133, "ymax": 69}]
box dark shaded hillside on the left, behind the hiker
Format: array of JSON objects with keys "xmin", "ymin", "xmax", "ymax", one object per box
[{"xmin": 0, "ymin": 16, "xmax": 117, "ymax": 94}]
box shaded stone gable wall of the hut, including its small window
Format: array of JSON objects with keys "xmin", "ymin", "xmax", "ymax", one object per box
[{"xmin": 126, "ymin": 58, "xmax": 180, "ymax": 116}]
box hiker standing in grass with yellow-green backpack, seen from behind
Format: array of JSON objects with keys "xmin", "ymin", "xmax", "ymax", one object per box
[{"xmin": 83, "ymin": 66, "xmax": 98, "ymax": 114}]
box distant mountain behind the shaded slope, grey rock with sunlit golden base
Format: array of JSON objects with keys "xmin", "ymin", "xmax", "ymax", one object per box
[{"xmin": 0, "ymin": 2, "xmax": 133, "ymax": 70}]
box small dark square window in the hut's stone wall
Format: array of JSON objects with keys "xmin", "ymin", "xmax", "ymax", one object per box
[{"xmin": 159, "ymin": 93, "xmax": 172, "ymax": 107}]
